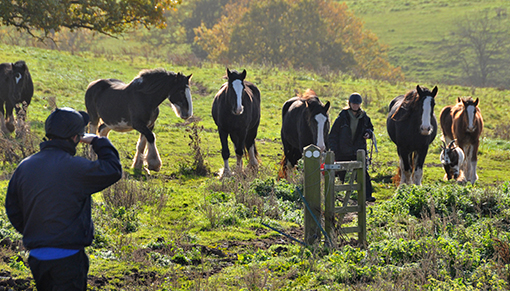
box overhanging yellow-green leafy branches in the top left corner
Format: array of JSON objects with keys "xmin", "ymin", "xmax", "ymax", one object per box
[{"xmin": 0, "ymin": 0, "xmax": 182, "ymax": 37}]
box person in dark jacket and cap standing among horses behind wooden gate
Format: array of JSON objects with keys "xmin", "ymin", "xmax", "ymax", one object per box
[{"xmin": 328, "ymin": 93, "xmax": 375, "ymax": 202}]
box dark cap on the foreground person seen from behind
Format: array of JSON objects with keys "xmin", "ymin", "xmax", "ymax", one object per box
[{"xmin": 44, "ymin": 107, "xmax": 89, "ymax": 139}]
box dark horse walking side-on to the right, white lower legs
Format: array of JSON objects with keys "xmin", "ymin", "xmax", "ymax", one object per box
[{"xmin": 85, "ymin": 69, "xmax": 193, "ymax": 171}]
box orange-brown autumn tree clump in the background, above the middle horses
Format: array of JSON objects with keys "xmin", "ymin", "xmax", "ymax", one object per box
[{"xmin": 195, "ymin": 0, "xmax": 403, "ymax": 81}]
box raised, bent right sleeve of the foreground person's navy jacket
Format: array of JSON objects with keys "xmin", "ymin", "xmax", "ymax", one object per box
[{"xmin": 81, "ymin": 137, "xmax": 122, "ymax": 193}]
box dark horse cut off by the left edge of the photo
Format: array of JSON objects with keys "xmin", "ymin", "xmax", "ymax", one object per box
[{"xmin": 0, "ymin": 61, "xmax": 34, "ymax": 134}]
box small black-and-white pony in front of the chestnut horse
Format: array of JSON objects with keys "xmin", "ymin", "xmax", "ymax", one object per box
[{"xmin": 440, "ymin": 140, "xmax": 464, "ymax": 181}]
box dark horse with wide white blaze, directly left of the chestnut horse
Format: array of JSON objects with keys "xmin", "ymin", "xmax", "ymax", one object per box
[{"xmin": 386, "ymin": 85, "xmax": 437, "ymax": 185}]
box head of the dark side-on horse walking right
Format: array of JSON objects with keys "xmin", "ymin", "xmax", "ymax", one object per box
[{"xmin": 168, "ymin": 73, "xmax": 193, "ymax": 119}]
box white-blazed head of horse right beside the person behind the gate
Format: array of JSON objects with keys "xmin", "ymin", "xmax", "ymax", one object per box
[{"xmin": 306, "ymin": 98, "xmax": 331, "ymax": 151}]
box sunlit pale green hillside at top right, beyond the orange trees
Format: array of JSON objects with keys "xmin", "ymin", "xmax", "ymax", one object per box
[{"xmin": 343, "ymin": 0, "xmax": 510, "ymax": 84}]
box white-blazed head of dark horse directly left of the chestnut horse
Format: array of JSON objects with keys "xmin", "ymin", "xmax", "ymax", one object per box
[{"xmin": 413, "ymin": 85, "xmax": 437, "ymax": 135}]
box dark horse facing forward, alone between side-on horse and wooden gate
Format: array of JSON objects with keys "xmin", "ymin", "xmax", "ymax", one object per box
[{"xmin": 212, "ymin": 68, "xmax": 260, "ymax": 177}]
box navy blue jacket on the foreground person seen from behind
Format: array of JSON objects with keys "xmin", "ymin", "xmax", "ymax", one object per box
[{"xmin": 5, "ymin": 138, "xmax": 122, "ymax": 249}]
